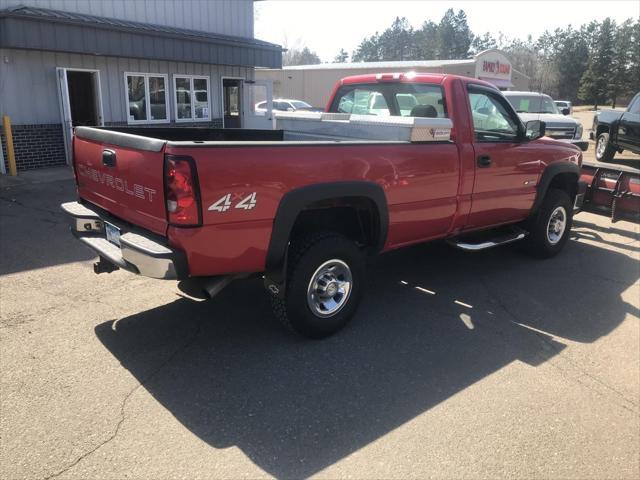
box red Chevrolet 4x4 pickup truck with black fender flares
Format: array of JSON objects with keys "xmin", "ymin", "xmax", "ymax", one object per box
[{"xmin": 62, "ymin": 74, "xmax": 585, "ymax": 338}]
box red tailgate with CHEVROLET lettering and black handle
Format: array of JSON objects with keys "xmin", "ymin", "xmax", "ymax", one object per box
[{"xmin": 73, "ymin": 127, "xmax": 167, "ymax": 235}]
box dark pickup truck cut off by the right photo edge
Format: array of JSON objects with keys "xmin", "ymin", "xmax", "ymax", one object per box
[{"xmin": 589, "ymin": 92, "xmax": 640, "ymax": 162}]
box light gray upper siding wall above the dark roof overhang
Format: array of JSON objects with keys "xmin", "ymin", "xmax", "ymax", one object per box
[{"xmin": 0, "ymin": 0, "xmax": 253, "ymax": 38}]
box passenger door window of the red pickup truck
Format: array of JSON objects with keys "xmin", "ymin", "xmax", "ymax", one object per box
[{"xmin": 469, "ymin": 91, "xmax": 518, "ymax": 142}]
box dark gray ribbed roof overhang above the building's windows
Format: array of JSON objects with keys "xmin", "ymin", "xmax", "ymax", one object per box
[{"xmin": 0, "ymin": 7, "xmax": 282, "ymax": 68}]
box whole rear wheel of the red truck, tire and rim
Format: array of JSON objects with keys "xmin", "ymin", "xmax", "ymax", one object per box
[{"xmin": 271, "ymin": 232, "xmax": 365, "ymax": 338}]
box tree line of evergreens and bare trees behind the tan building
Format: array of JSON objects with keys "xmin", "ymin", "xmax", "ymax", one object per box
[{"xmin": 283, "ymin": 9, "xmax": 640, "ymax": 106}]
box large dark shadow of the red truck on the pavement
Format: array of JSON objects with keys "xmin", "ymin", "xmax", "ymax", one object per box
[{"xmin": 96, "ymin": 238, "xmax": 638, "ymax": 477}]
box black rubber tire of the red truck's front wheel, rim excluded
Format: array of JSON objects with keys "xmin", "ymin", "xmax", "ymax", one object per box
[{"xmin": 522, "ymin": 188, "xmax": 573, "ymax": 258}]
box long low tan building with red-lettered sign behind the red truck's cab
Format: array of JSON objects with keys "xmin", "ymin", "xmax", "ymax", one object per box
[{"xmin": 256, "ymin": 50, "xmax": 529, "ymax": 107}]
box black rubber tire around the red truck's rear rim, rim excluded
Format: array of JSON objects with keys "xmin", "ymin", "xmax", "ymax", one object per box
[{"xmin": 271, "ymin": 232, "xmax": 365, "ymax": 338}]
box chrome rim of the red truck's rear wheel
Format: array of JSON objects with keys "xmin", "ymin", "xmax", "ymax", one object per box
[{"xmin": 307, "ymin": 259, "xmax": 353, "ymax": 318}]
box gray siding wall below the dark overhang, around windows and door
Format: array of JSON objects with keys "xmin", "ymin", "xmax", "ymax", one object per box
[{"xmin": 0, "ymin": 49, "xmax": 253, "ymax": 125}]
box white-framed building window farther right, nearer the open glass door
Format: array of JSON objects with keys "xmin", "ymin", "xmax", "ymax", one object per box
[{"xmin": 173, "ymin": 75, "xmax": 211, "ymax": 122}]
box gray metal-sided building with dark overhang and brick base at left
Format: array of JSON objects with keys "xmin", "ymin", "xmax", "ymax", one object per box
[{"xmin": 0, "ymin": 0, "xmax": 282, "ymax": 169}]
